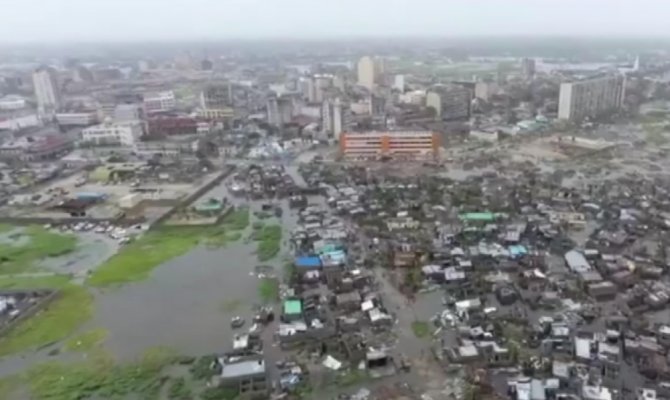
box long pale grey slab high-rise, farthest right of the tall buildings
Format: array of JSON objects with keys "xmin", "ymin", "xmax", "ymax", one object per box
[{"xmin": 558, "ymin": 74, "xmax": 626, "ymax": 121}]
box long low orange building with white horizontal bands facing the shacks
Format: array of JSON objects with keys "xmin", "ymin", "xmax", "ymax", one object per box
[{"xmin": 340, "ymin": 131, "xmax": 440, "ymax": 159}]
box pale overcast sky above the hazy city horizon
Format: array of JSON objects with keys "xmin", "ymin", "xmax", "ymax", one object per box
[{"xmin": 0, "ymin": 0, "xmax": 670, "ymax": 42}]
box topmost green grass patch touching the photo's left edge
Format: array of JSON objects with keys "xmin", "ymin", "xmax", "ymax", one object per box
[{"xmin": 0, "ymin": 226, "xmax": 77, "ymax": 274}]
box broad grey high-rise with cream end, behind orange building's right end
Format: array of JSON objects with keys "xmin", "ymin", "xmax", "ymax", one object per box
[{"xmin": 426, "ymin": 84, "xmax": 472, "ymax": 121}]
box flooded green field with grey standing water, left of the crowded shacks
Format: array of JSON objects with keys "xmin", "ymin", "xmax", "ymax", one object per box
[{"xmin": 0, "ymin": 198, "xmax": 295, "ymax": 400}]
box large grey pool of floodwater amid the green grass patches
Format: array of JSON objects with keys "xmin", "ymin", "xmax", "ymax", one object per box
[{"xmin": 89, "ymin": 202, "xmax": 297, "ymax": 359}]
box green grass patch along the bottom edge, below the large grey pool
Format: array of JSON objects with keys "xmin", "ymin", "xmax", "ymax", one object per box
[{"xmin": 24, "ymin": 348, "xmax": 174, "ymax": 400}]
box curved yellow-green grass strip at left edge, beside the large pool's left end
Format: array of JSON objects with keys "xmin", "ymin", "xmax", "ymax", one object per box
[{"xmin": 0, "ymin": 280, "xmax": 93, "ymax": 356}]
